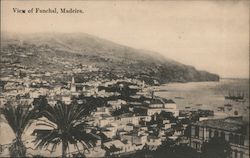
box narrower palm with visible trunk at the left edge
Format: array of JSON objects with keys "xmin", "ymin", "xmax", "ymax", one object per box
[{"xmin": 0, "ymin": 105, "xmax": 35, "ymax": 157}]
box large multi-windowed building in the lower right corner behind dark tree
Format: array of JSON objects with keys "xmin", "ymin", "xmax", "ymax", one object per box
[{"xmin": 189, "ymin": 118, "xmax": 249, "ymax": 158}]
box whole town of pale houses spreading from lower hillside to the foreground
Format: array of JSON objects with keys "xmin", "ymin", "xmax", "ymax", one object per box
[{"xmin": 0, "ymin": 54, "xmax": 249, "ymax": 158}]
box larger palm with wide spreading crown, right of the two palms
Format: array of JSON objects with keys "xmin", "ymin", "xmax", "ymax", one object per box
[{"xmin": 33, "ymin": 101, "xmax": 97, "ymax": 157}]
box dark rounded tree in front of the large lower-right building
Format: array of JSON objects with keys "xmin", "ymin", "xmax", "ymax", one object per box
[{"xmin": 201, "ymin": 136, "xmax": 231, "ymax": 158}]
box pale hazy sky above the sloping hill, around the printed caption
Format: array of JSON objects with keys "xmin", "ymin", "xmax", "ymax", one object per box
[{"xmin": 1, "ymin": 1, "xmax": 249, "ymax": 78}]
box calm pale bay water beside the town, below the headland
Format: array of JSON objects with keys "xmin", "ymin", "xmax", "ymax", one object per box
[{"xmin": 155, "ymin": 79, "xmax": 249, "ymax": 118}]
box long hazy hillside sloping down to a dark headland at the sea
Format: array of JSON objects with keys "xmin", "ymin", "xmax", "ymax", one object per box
[{"xmin": 1, "ymin": 33, "xmax": 219, "ymax": 83}]
